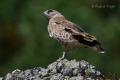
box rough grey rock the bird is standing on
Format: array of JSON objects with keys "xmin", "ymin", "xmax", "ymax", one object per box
[{"xmin": 3, "ymin": 59, "xmax": 103, "ymax": 80}]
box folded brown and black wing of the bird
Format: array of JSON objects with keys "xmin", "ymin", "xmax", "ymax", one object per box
[{"xmin": 64, "ymin": 20, "xmax": 99, "ymax": 46}]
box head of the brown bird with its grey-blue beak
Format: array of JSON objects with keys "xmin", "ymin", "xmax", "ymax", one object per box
[{"xmin": 43, "ymin": 9, "xmax": 62, "ymax": 19}]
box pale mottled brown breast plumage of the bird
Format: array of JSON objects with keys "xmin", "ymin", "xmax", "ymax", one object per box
[{"xmin": 48, "ymin": 19, "xmax": 74, "ymax": 42}]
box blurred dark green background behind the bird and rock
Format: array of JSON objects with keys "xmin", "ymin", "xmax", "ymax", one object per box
[{"xmin": 0, "ymin": 0, "xmax": 120, "ymax": 76}]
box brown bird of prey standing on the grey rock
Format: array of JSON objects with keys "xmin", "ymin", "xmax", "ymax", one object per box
[{"xmin": 44, "ymin": 9, "xmax": 104, "ymax": 59}]
